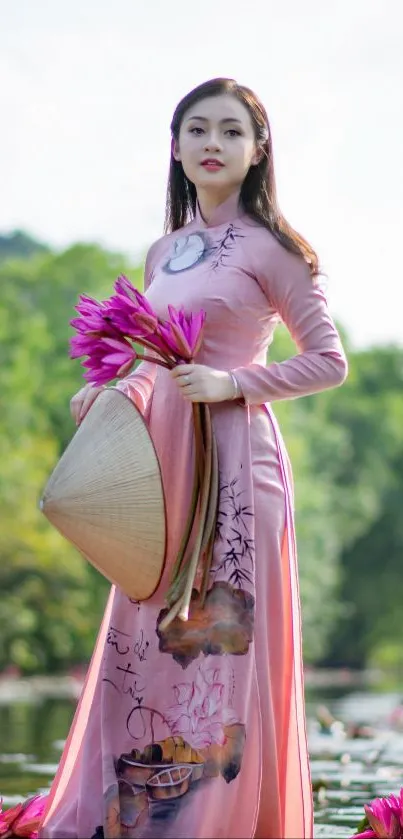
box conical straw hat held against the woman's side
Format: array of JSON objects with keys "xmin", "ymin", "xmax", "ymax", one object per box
[{"xmin": 40, "ymin": 388, "xmax": 166, "ymax": 600}]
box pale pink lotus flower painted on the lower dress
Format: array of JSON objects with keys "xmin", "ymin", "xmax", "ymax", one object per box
[{"xmin": 166, "ymin": 665, "xmax": 239, "ymax": 749}]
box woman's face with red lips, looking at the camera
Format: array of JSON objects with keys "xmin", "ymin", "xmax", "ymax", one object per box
[{"xmin": 173, "ymin": 94, "xmax": 259, "ymax": 194}]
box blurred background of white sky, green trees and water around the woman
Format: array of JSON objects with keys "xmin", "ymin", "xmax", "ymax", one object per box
[{"xmin": 0, "ymin": 0, "xmax": 403, "ymax": 836}]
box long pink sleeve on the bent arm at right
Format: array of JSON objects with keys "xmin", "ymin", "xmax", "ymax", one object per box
[{"xmin": 233, "ymin": 242, "xmax": 348, "ymax": 405}]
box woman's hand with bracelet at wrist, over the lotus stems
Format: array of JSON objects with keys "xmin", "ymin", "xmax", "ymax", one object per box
[{"xmin": 170, "ymin": 364, "xmax": 234, "ymax": 402}]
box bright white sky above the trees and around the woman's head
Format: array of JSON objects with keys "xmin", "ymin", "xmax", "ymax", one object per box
[{"xmin": 0, "ymin": 0, "xmax": 403, "ymax": 346}]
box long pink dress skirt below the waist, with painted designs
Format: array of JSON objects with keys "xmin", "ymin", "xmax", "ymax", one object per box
[{"xmin": 39, "ymin": 388, "xmax": 312, "ymax": 839}]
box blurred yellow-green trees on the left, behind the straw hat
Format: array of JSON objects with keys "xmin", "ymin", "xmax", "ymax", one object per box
[{"xmin": 0, "ymin": 240, "xmax": 142, "ymax": 672}]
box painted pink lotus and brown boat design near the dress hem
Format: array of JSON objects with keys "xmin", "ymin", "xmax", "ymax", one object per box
[{"xmin": 104, "ymin": 663, "xmax": 246, "ymax": 837}]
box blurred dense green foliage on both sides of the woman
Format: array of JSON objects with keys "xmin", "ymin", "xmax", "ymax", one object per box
[{"xmin": 0, "ymin": 233, "xmax": 403, "ymax": 672}]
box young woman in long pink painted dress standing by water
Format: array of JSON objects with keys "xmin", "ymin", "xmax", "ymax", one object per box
[{"xmin": 32, "ymin": 79, "xmax": 347, "ymax": 839}]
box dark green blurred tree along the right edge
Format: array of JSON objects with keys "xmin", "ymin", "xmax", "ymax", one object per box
[{"xmin": 323, "ymin": 346, "xmax": 403, "ymax": 667}]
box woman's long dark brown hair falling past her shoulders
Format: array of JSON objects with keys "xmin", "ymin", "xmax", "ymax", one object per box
[{"xmin": 164, "ymin": 78, "xmax": 321, "ymax": 277}]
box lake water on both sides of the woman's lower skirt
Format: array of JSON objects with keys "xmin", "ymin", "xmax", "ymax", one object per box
[{"xmin": 0, "ymin": 688, "xmax": 403, "ymax": 839}]
